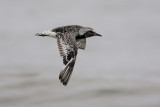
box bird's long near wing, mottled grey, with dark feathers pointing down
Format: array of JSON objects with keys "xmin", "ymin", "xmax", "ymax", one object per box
[{"xmin": 57, "ymin": 33, "xmax": 78, "ymax": 85}]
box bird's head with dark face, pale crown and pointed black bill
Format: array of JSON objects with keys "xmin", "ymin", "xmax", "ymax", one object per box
[{"xmin": 79, "ymin": 27, "xmax": 101, "ymax": 38}]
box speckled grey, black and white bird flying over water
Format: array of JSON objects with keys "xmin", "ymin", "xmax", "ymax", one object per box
[{"xmin": 36, "ymin": 25, "xmax": 101, "ymax": 86}]
